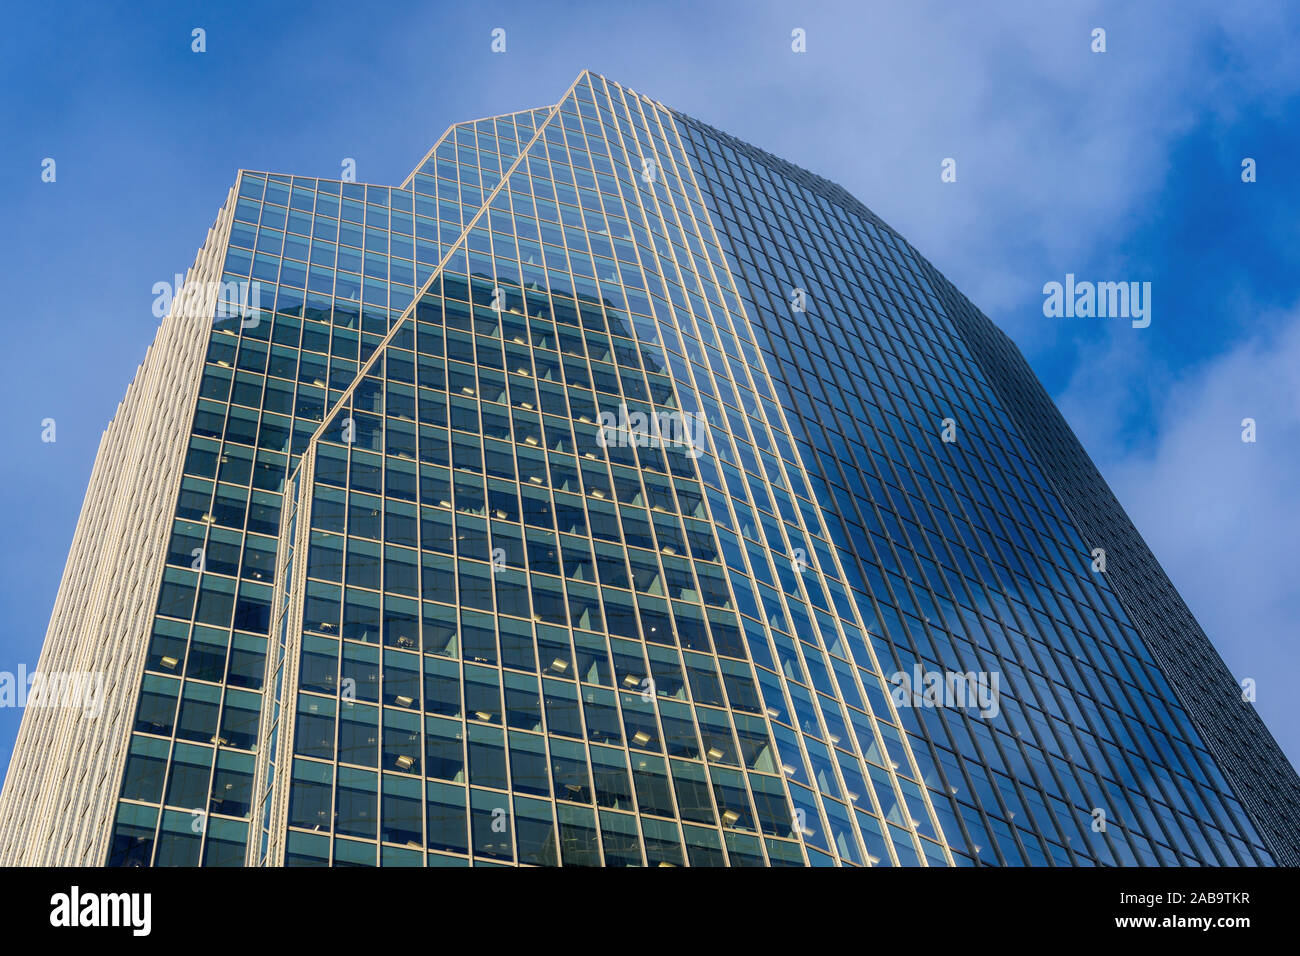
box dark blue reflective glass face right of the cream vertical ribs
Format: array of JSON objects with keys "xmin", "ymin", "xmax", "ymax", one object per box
[{"xmin": 686, "ymin": 124, "xmax": 1270, "ymax": 866}]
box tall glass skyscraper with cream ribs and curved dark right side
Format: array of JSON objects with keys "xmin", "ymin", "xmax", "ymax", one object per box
[{"xmin": 0, "ymin": 73, "xmax": 1300, "ymax": 866}]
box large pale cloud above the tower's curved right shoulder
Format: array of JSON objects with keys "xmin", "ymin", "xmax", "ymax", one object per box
[{"xmin": 593, "ymin": 0, "xmax": 1300, "ymax": 343}]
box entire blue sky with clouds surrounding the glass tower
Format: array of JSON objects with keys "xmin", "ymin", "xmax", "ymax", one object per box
[{"xmin": 0, "ymin": 1, "xmax": 1300, "ymax": 785}]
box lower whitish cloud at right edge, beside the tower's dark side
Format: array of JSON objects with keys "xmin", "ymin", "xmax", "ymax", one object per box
[{"xmin": 1060, "ymin": 307, "xmax": 1300, "ymax": 761}]
